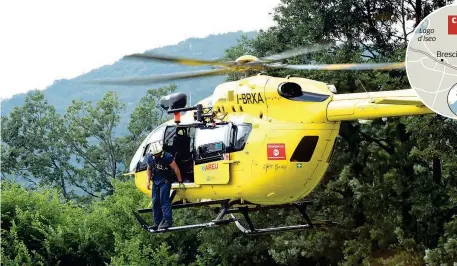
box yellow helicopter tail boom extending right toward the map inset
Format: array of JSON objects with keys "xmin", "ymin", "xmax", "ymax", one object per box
[{"xmin": 327, "ymin": 89, "xmax": 433, "ymax": 121}]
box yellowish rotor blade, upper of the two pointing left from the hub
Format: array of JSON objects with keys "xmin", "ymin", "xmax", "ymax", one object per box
[{"xmin": 124, "ymin": 54, "xmax": 234, "ymax": 66}]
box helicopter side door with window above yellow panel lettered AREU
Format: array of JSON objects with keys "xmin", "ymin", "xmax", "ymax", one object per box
[{"xmin": 194, "ymin": 124, "xmax": 231, "ymax": 184}]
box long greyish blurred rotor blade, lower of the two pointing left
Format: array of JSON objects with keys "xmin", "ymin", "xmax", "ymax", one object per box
[{"xmin": 86, "ymin": 69, "xmax": 229, "ymax": 85}]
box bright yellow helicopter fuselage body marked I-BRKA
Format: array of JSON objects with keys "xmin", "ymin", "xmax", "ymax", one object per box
[{"xmin": 135, "ymin": 75, "xmax": 430, "ymax": 205}]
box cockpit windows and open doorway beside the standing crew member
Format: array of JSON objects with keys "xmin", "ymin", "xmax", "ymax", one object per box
[{"xmin": 130, "ymin": 123, "xmax": 252, "ymax": 183}]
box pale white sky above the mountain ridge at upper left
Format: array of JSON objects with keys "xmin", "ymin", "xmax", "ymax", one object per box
[{"xmin": 0, "ymin": 0, "xmax": 280, "ymax": 99}]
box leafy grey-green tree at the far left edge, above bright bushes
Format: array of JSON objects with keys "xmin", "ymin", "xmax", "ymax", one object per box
[{"xmin": 1, "ymin": 91, "xmax": 81, "ymax": 198}]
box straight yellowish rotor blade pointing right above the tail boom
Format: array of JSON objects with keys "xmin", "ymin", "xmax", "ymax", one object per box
[{"xmin": 265, "ymin": 62, "xmax": 405, "ymax": 70}]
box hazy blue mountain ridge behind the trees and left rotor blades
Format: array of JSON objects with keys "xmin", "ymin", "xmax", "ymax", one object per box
[{"xmin": 1, "ymin": 31, "xmax": 257, "ymax": 133}]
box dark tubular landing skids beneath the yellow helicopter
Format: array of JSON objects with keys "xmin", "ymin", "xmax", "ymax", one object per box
[{"xmin": 133, "ymin": 200, "xmax": 335, "ymax": 235}]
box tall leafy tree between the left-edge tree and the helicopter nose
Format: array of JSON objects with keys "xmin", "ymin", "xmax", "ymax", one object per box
[{"xmin": 64, "ymin": 91, "xmax": 125, "ymax": 195}]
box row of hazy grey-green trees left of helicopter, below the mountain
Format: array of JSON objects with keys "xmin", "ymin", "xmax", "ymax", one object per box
[{"xmin": 1, "ymin": 85, "xmax": 176, "ymax": 200}]
